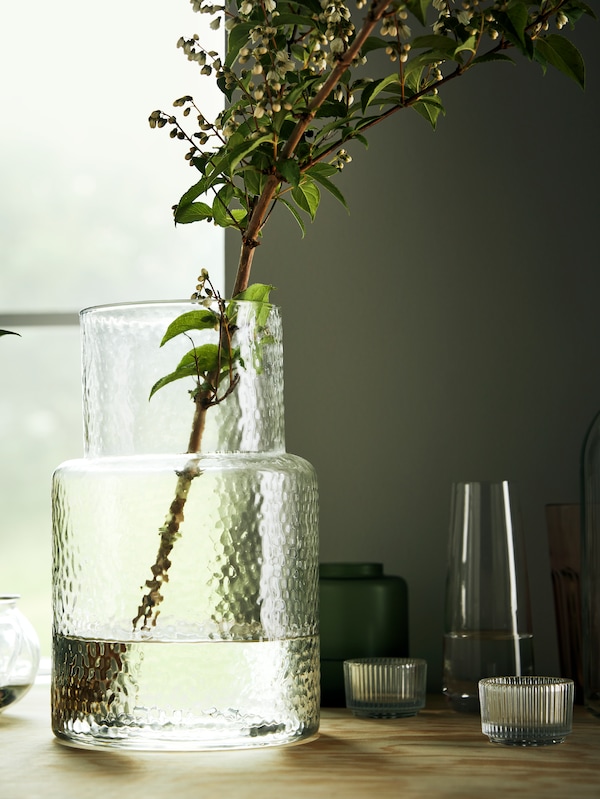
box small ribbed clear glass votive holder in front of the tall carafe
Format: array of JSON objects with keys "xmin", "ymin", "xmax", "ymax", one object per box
[{"xmin": 479, "ymin": 677, "xmax": 574, "ymax": 746}]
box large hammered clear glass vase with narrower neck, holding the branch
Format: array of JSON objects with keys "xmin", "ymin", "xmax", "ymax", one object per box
[{"xmin": 52, "ymin": 302, "xmax": 319, "ymax": 750}]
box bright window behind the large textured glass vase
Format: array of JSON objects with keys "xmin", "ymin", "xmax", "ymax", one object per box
[{"xmin": 0, "ymin": 0, "xmax": 224, "ymax": 654}]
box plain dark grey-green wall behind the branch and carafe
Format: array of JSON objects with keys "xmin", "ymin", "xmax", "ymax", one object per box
[{"xmin": 226, "ymin": 22, "xmax": 600, "ymax": 689}]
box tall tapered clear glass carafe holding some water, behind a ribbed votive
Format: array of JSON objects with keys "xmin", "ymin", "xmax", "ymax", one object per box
[{"xmin": 443, "ymin": 480, "xmax": 534, "ymax": 713}]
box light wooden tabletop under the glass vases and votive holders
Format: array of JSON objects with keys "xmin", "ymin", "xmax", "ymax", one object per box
[{"xmin": 0, "ymin": 685, "xmax": 600, "ymax": 799}]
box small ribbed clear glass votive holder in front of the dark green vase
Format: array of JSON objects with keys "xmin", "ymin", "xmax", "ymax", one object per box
[{"xmin": 344, "ymin": 658, "xmax": 427, "ymax": 719}]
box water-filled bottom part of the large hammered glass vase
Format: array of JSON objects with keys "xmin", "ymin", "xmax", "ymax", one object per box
[{"xmin": 52, "ymin": 635, "xmax": 319, "ymax": 751}]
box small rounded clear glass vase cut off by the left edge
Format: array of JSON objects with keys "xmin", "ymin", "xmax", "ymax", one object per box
[{"xmin": 0, "ymin": 594, "xmax": 40, "ymax": 711}]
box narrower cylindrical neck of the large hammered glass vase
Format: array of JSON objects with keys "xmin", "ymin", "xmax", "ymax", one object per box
[{"xmin": 81, "ymin": 301, "xmax": 285, "ymax": 456}]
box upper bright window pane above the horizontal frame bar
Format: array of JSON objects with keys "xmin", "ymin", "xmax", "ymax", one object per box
[{"xmin": 0, "ymin": 0, "xmax": 224, "ymax": 310}]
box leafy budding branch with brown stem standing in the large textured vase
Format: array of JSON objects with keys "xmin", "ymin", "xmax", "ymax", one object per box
[{"xmin": 134, "ymin": 0, "xmax": 594, "ymax": 628}]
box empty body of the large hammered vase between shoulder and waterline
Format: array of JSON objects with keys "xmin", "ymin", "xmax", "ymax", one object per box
[{"xmin": 53, "ymin": 453, "xmax": 318, "ymax": 640}]
